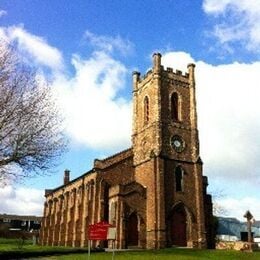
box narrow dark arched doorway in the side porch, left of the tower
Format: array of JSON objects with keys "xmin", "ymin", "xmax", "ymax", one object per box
[{"xmin": 127, "ymin": 213, "xmax": 138, "ymax": 246}]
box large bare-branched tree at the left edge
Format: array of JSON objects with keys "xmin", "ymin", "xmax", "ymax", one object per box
[{"xmin": 0, "ymin": 41, "xmax": 66, "ymax": 184}]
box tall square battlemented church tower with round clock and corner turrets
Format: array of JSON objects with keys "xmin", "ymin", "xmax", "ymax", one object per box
[{"xmin": 132, "ymin": 53, "xmax": 209, "ymax": 248}]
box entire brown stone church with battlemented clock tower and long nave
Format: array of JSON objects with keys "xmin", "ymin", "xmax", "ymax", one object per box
[{"xmin": 40, "ymin": 53, "xmax": 214, "ymax": 248}]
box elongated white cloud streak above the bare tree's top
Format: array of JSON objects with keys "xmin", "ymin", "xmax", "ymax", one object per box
[{"xmin": 0, "ymin": 26, "xmax": 63, "ymax": 72}]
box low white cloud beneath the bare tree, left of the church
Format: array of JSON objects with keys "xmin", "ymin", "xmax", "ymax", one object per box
[{"xmin": 0, "ymin": 186, "xmax": 44, "ymax": 216}]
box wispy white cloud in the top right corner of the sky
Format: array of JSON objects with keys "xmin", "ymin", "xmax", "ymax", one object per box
[{"xmin": 203, "ymin": 0, "xmax": 260, "ymax": 52}]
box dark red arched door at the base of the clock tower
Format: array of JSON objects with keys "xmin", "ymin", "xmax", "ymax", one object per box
[{"xmin": 170, "ymin": 205, "xmax": 187, "ymax": 246}]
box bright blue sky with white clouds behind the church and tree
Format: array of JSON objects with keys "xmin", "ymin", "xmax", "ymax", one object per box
[{"xmin": 0, "ymin": 0, "xmax": 260, "ymax": 219}]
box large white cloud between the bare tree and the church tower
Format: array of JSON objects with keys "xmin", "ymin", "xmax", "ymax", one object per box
[{"xmin": 54, "ymin": 48, "xmax": 132, "ymax": 150}]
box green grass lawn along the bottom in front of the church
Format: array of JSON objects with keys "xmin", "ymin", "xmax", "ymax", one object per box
[{"xmin": 0, "ymin": 238, "xmax": 260, "ymax": 260}]
